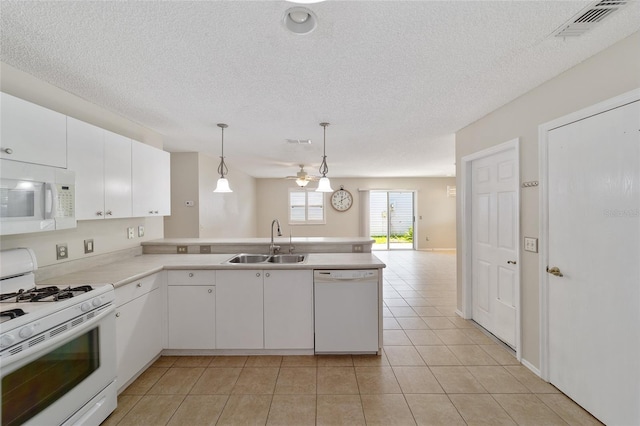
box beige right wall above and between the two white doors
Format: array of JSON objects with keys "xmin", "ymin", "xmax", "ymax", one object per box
[{"xmin": 456, "ymin": 32, "xmax": 640, "ymax": 368}]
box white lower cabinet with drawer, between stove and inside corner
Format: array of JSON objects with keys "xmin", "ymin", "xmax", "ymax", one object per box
[{"xmin": 115, "ymin": 274, "xmax": 162, "ymax": 391}]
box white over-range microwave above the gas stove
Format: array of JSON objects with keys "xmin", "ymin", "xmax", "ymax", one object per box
[{"xmin": 0, "ymin": 159, "xmax": 76, "ymax": 235}]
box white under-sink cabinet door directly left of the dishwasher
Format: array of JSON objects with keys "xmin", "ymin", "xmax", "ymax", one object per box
[{"xmin": 264, "ymin": 270, "xmax": 313, "ymax": 349}]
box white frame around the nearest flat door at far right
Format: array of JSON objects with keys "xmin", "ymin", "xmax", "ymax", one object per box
[{"xmin": 538, "ymin": 89, "xmax": 640, "ymax": 381}]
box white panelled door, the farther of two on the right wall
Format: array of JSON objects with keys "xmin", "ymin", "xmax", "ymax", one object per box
[{"xmin": 471, "ymin": 148, "xmax": 520, "ymax": 348}]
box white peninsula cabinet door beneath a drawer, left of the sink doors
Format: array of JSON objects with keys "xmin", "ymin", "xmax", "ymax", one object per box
[{"xmin": 167, "ymin": 285, "xmax": 216, "ymax": 349}]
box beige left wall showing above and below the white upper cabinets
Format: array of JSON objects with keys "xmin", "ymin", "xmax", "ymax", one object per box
[{"xmin": 0, "ymin": 63, "xmax": 168, "ymax": 266}]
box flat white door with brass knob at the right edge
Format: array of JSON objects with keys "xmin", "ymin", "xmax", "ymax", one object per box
[{"xmin": 547, "ymin": 98, "xmax": 640, "ymax": 425}]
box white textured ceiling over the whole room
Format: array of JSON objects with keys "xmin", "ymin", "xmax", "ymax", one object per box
[{"xmin": 0, "ymin": 0, "xmax": 640, "ymax": 178}]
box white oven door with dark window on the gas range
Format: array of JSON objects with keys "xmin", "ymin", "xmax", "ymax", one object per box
[{"xmin": 1, "ymin": 305, "xmax": 117, "ymax": 426}]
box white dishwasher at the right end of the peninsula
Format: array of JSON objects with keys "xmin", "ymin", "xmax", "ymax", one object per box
[{"xmin": 313, "ymin": 269, "xmax": 380, "ymax": 354}]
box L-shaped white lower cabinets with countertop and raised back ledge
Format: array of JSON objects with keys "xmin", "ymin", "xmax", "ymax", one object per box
[{"xmin": 38, "ymin": 238, "xmax": 385, "ymax": 391}]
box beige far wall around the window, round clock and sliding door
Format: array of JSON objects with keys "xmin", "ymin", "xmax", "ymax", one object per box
[{"xmin": 257, "ymin": 178, "xmax": 456, "ymax": 249}]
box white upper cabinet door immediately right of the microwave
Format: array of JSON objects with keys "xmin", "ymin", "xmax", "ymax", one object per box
[{"xmin": 67, "ymin": 117, "xmax": 104, "ymax": 220}]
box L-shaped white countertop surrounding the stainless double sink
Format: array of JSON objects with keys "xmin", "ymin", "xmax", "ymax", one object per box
[{"xmin": 38, "ymin": 253, "xmax": 386, "ymax": 287}]
